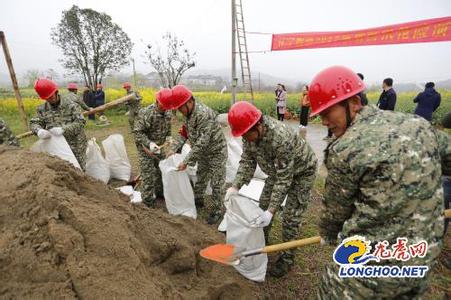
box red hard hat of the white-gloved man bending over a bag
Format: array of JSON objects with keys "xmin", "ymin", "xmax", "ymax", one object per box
[{"xmin": 227, "ymin": 101, "xmax": 262, "ymax": 137}]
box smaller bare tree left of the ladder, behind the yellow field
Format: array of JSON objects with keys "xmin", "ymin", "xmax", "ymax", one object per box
[{"xmin": 146, "ymin": 32, "xmax": 196, "ymax": 88}]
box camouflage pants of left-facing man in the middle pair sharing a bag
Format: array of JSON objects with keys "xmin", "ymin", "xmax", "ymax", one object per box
[{"xmin": 194, "ymin": 148, "xmax": 227, "ymax": 212}]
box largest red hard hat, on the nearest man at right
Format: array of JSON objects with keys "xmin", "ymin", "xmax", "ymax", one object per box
[{"xmin": 308, "ymin": 66, "xmax": 365, "ymax": 117}]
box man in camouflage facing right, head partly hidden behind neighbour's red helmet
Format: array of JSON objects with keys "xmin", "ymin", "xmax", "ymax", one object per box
[{"xmin": 133, "ymin": 89, "xmax": 172, "ymax": 207}]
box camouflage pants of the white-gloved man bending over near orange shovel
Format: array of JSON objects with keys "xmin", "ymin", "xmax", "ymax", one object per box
[{"xmin": 260, "ymin": 175, "xmax": 315, "ymax": 264}]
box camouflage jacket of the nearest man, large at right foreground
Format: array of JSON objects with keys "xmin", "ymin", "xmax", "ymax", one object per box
[{"xmin": 320, "ymin": 105, "xmax": 451, "ymax": 257}]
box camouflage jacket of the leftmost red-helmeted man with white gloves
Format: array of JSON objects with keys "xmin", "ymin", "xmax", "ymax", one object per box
[{"xmin": 30, "ymin": 95, "xmax": 87, "ymax": 148}]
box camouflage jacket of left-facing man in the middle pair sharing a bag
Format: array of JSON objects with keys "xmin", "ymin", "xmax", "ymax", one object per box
[{"xmin": 174, "ymin": 101, "xmax": 227, "ymax": 165}]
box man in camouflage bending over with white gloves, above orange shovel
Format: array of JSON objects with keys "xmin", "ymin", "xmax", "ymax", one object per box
[{"xmin": 226, "ymin": 102, "xmax": 317, "ymax": 277}]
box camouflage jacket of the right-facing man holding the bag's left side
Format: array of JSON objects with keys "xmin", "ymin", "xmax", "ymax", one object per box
[{"xmin": 133, "ymin": 104, "xmax": 171, "ymax": 152}]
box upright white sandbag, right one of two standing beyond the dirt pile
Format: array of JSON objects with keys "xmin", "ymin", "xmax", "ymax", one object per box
[{"xmin": 102, "ymin": 134, "xmax": 132, "ymax": 181}]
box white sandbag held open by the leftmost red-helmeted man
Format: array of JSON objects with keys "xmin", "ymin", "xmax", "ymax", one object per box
[{"xmin": 31, "ymin": 134, "xmax": 81, "ymax": 169}]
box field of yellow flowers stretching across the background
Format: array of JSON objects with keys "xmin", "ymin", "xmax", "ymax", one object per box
[{"xmin": 0, "ymin": 88, "xmax": 451, "ymax": 123}]
